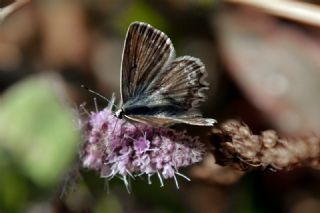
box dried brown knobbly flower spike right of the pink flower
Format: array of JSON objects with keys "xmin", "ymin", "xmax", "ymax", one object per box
[{"xmin": 211, "ymin": 120, "xmax": 320, "ymax": 170}]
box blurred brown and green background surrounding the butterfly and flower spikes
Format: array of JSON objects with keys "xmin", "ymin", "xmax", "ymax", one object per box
[{"xmin": 0, "ymin": 0, "xmax": 320, "ymax": 213}]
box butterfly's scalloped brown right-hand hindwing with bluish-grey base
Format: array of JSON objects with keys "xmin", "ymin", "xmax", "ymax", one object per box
[{"xmin": 124, "ymin": 56, "xmax": 208, "ymax": 117}]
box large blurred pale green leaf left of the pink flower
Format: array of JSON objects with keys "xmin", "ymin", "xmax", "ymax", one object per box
[{"xmin": 0, "ymin": 76, "xmax": 79, "ymax": 187}]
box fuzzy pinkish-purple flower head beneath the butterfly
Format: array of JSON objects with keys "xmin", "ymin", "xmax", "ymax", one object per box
[{"xmin": 80, "ymin": 98, "xmax": 205, "ymax": 190}]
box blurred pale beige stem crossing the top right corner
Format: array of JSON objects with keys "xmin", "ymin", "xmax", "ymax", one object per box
[{"xmin": 225, "ymin": 0, "xmax": 320, "ymax": 27}]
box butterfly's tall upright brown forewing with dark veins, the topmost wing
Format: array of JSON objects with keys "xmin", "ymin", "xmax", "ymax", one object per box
[{"xmin": 121, "ymin": 22, "xmax": 174, "ymax": 103}]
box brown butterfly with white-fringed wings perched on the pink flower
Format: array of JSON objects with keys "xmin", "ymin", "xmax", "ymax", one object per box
[{"xmin": 115, "ymin": 22, "xmax": 216, "ymax": 126}]
